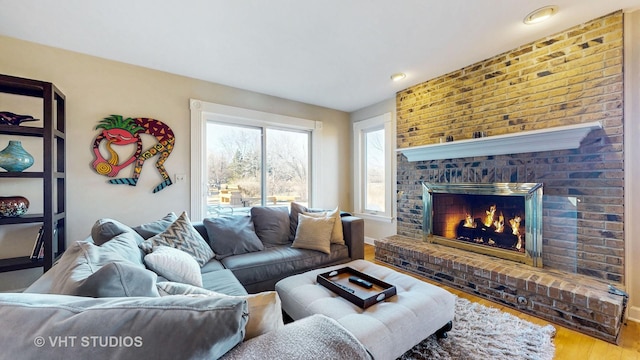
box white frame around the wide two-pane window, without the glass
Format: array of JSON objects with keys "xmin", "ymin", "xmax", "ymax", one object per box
[{"xmin": 190, "ymin": 99, "xmax": 322, "ymax": 221}]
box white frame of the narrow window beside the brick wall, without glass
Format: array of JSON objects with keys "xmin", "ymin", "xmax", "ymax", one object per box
[{"xmin": 353, "ymin": 112, "xmax": 395, "ymax": 222}]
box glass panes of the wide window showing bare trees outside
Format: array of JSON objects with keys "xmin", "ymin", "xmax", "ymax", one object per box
[{"xmin": 205, "ymin": 123, "xmax": 310, "ymax": 216}]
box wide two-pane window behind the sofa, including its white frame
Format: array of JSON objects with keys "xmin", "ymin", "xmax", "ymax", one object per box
[{"xmin": 191, "ymin": 100, "xmax": 322, "ymax": 219}]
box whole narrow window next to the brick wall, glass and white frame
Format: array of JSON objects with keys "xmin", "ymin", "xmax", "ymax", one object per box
[{"xmin": 353, "ymin": 113, "xmax": 393, "ymax": 220}]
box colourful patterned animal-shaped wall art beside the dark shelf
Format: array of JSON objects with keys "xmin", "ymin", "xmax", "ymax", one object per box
[{"xmin": 91, "ymin": 115, "xmax": 175, "ymax": 193}]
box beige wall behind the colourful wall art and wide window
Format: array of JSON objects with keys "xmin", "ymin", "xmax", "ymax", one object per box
[{"xmin": 0, "ymin": 36, "xmax": 351, "ymax": 291}]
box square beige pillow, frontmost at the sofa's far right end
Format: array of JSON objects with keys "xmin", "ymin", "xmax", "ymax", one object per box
[{"xmin": 291, "ymin": 214, "xmax": 335, "ymax": 254}]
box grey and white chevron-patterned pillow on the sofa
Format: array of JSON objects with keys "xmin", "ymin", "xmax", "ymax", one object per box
[{"xmin": 138, "ymin": 212, "xmax": 215, "ymax": 267}]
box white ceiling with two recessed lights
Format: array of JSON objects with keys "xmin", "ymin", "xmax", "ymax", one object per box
[{"xmin": 0, "ymin": 0, "xmax": 640, "ymax": 112}]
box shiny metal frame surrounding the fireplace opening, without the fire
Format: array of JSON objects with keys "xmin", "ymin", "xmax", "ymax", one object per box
[{"xmin": 422, "ymin": 182, "xmax": 543, "ymax": 267}]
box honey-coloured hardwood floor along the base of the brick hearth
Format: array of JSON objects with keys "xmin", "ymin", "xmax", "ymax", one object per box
[{"xmin": 364, "ymin": 244, "xmax": 640, "ymax": 360}]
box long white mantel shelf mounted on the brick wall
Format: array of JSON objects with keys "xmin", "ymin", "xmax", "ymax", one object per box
[{"xmin": 396, "ymin": 121, "xmax": 602, "ymax": 161}]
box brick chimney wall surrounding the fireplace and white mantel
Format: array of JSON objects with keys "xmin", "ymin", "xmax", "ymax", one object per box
[{"xmin": 396, "ymin": 11, "xmax": 624, "ymax": 282}]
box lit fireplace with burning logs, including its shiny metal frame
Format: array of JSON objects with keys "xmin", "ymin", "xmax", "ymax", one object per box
[{"xmin": 423, "ymin": 183, "xmax": 542, "ymax": 266}]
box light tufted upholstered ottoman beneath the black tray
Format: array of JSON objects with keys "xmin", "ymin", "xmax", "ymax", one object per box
[{"xmin": 276, "ymin": 260, "xmax": 455, "ymax": 360}]
